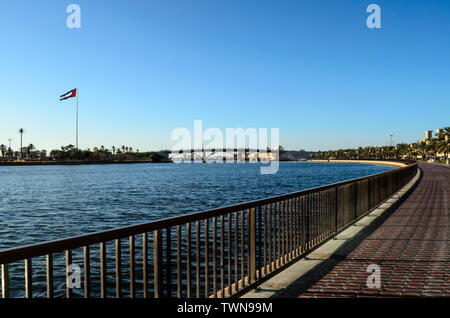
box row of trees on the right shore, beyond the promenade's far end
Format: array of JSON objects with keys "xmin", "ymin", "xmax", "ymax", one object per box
[{"xmin": 316, "ymin": 127, "xmax": 450, "ymax": 161}]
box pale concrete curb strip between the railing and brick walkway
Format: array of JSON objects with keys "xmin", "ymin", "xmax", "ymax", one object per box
[{"xmin": 241, "ymin": 169, "xmax": 422, "ymax": 298}]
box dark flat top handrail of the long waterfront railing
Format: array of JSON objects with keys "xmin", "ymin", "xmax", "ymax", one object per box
[{"xmin": 0, "ymin": 163, "xmax": 417, "ymax": 264}]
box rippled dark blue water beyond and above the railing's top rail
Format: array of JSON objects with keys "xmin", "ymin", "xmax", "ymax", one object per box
[{"xmin": 0, "ymin": 162, "xmax": 391, "ymax": 250}]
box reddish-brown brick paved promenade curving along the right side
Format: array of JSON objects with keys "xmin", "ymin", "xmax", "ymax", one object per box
[{"xmin": 295, "ymin": 164, "xmax": 450, "ymax": 297}]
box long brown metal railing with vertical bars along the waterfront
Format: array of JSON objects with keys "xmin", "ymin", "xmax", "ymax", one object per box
[{"xmin": 0, "ymin": 164, "xmax": 418, "ymax": 298}]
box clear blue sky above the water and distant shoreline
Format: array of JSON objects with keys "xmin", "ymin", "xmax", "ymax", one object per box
[{"xmin": 0, "ymin": 0, "xmax": 450, "ymax": 151}]
